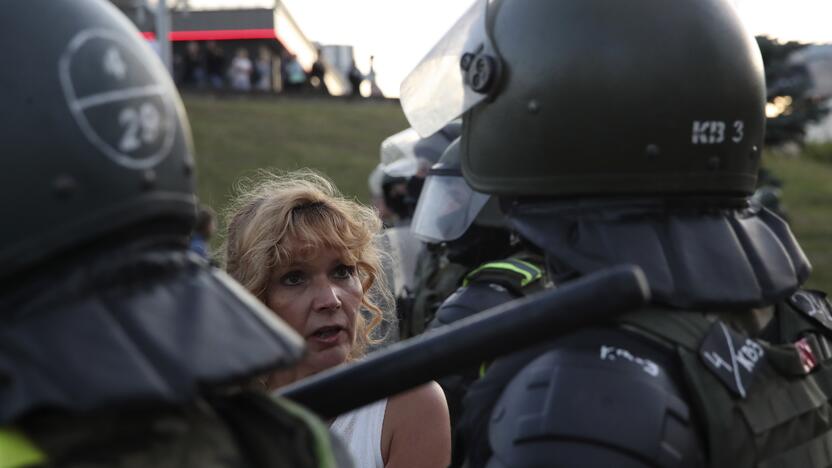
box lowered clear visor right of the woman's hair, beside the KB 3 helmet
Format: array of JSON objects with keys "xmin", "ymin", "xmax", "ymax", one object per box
[{"xmin": 410, "ymin": 174, "xmax": 490, "ymax": 243}]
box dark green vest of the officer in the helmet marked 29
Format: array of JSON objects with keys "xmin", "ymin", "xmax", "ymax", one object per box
[{"xmin": 0, "ymin": 393, "xmax": 343, "ymax": 468}]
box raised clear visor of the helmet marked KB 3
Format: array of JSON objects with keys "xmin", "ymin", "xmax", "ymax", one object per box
[{"xmin": 400, "ymin": 0, "xmax": 493, "ymax": 137}]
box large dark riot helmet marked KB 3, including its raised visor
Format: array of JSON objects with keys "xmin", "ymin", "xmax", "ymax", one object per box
[{"xmin": 401, "ymin": 0, "xmax": 766, "ymax": 198}]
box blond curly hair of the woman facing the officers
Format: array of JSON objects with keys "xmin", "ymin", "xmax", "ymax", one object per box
[{"xmin": 223, "ymin": 169, "xmax": 390, "ymax": 359}]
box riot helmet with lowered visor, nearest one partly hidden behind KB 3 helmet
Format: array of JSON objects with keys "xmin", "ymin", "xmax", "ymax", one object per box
[{"xmin": 410, "ymin": 138, "xmax": 505, "ymax": 243}]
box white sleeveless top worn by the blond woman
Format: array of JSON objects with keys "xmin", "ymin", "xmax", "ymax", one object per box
[{"xmin": 330, "ymin": 398, "xmax": 387, "ymax": 468}]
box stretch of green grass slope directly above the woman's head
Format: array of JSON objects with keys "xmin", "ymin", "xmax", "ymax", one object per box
[{"xmin": 184, "ymin": 95, "xmax": 408, "ymax": 211}]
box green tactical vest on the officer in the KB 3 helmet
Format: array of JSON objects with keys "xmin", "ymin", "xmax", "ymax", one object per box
[{"xmin": 620, "ymin": 292, "xmax": 832, "ymax": 468}]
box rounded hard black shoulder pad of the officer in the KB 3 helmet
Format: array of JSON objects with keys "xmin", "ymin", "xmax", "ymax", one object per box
[{"xmin": 489, "ymin": 345, "xmax": 702, "ymax": 467}]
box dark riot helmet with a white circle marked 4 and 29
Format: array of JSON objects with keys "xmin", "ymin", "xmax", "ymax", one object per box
[{"xmin": 0, "ymin": 0, "xmax": 195, "ymax": 278}]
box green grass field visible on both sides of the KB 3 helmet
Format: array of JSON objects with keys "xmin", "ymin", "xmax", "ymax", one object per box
[{"xmin": 185, "ymin": 95, "xmax": 832, "ymax": 291}]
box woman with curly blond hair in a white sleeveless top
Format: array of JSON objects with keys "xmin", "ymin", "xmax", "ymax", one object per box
[{"xmin": 225, "ymin": 170, "xmax": 451, "ymax": 468}]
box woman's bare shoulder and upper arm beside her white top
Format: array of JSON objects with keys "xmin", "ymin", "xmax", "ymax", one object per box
[{"xmin": 382, "ymin": 382, "xmax": 451, "ymax": 466}]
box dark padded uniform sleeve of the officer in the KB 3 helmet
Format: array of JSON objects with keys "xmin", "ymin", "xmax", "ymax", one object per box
[{"xmin": 462, "ymin": 329, "xmax": 704, "ymax": 467}]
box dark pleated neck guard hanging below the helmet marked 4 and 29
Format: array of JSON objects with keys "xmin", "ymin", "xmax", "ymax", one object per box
[{"xmin": 0, "ymin": 251, "xmax": 303, "ymax": 424}]
